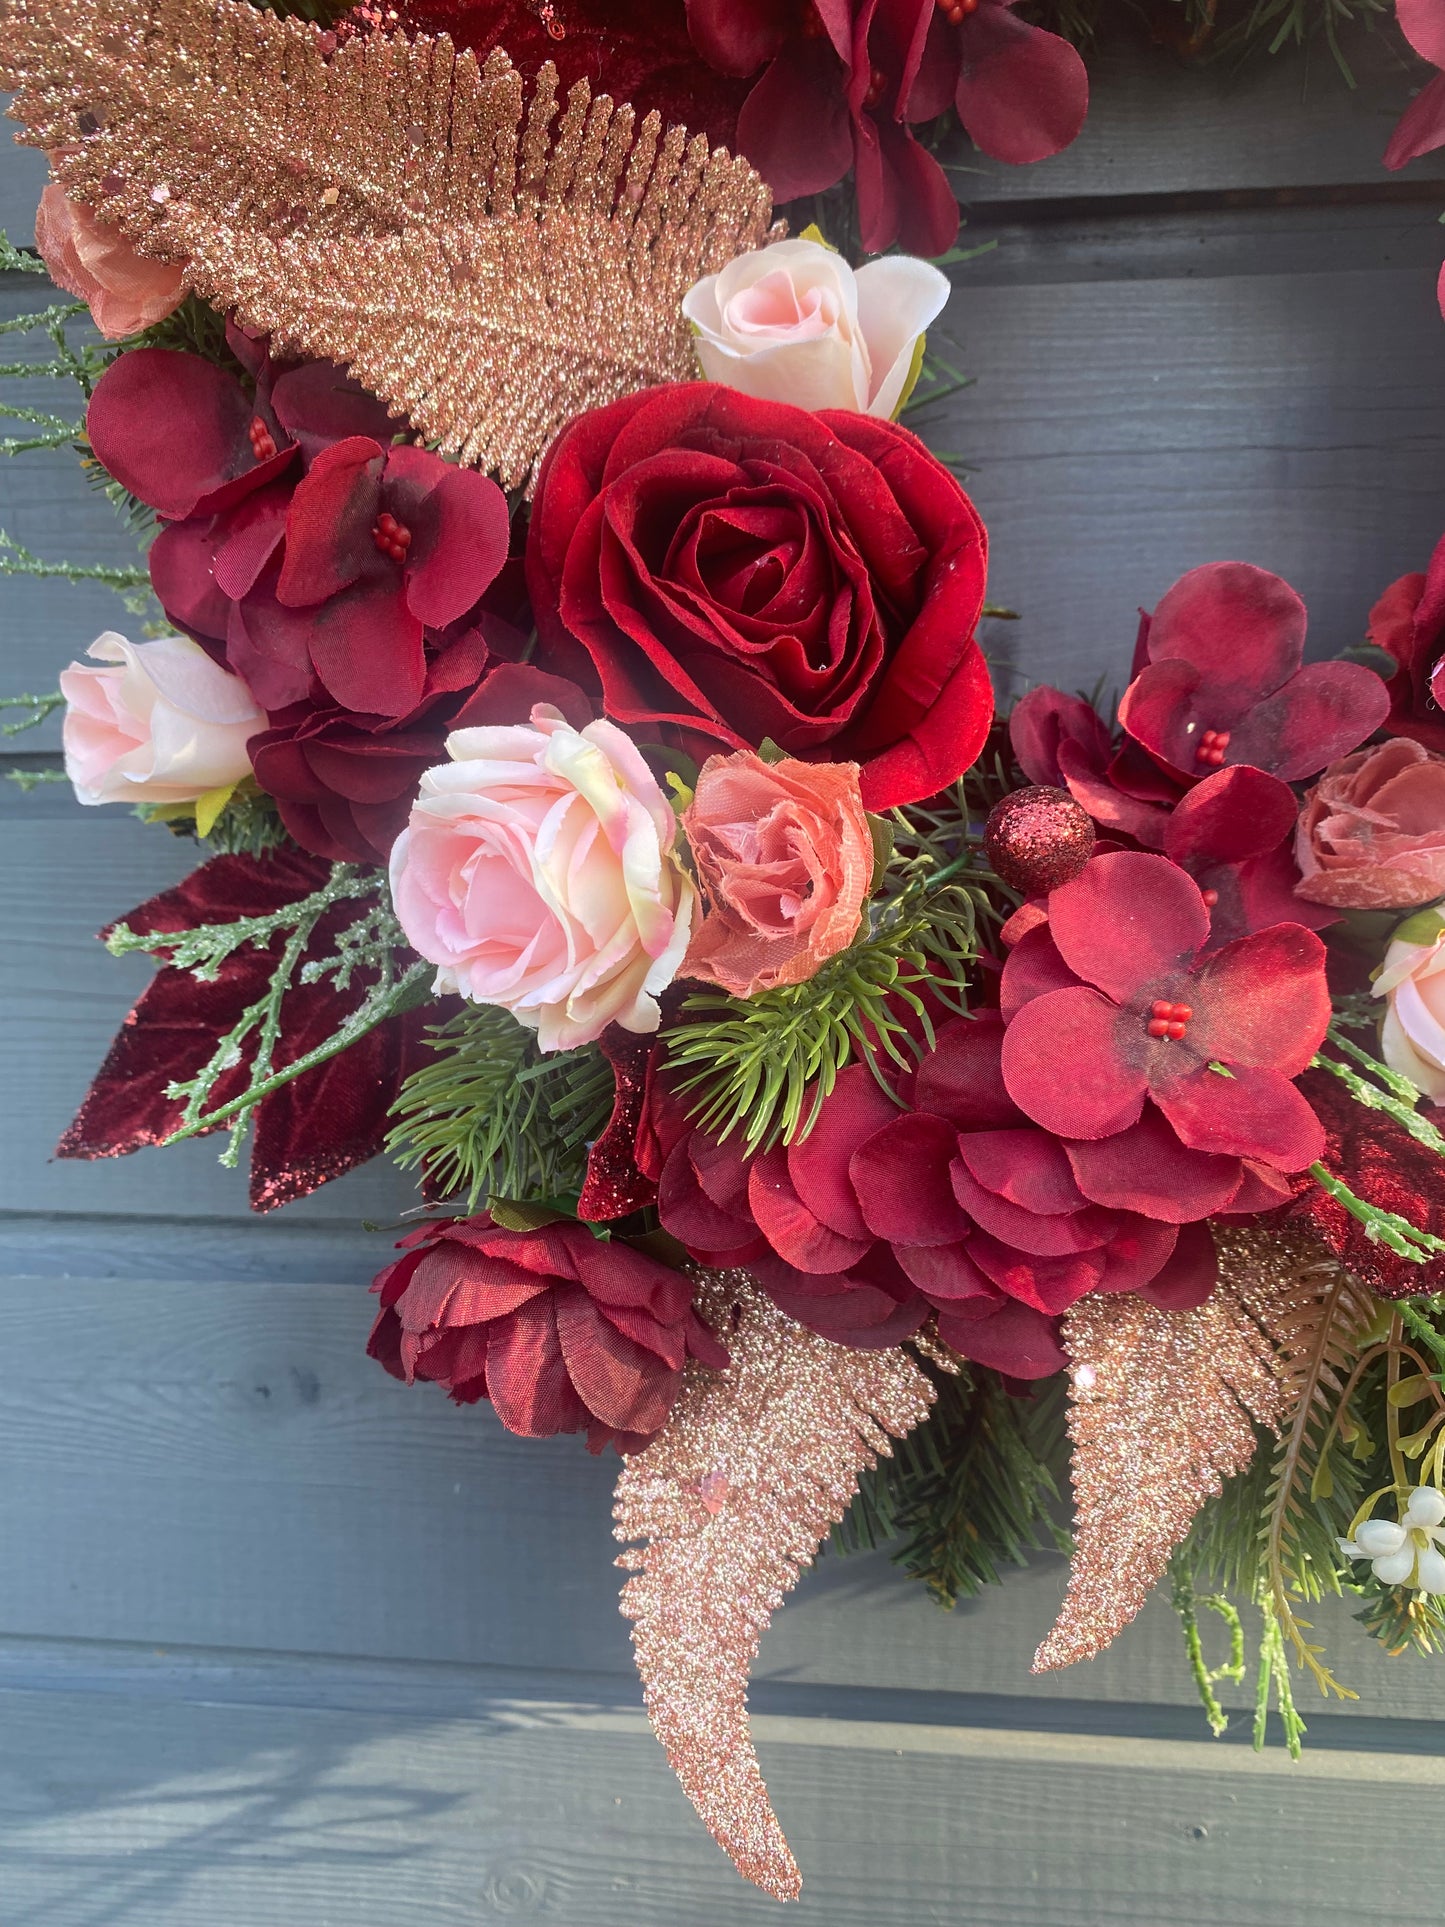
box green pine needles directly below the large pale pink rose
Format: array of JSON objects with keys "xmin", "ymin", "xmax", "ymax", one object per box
[{"xmin": 387, "ymin": 1004, "xmax": 613, "ymax": 1212}]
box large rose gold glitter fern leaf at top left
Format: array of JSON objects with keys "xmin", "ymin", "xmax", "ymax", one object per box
[{"xmin": 0, "ymin": 0, "xmax": 771, "ymax": 484}]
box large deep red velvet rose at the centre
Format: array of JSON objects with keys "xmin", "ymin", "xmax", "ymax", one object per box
[{"xmin": 528, "ymin": 382, "xmax": 992, "ymax": 809}]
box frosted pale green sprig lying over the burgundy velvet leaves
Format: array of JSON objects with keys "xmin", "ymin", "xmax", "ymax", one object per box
[{"xmin": 106, "ymin": 863, "xmax": 434, "ymax": 1166}]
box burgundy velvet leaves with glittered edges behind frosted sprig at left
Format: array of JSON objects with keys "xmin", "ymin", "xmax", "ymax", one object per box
[{"xmin": 56, "ymin": 850, "xmax": 437, "ymax": 1210}]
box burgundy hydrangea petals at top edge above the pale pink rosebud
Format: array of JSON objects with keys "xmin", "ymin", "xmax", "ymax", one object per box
[{"xmin": 688, "ymin": 0, "xmax": 958, "ymax": 254}]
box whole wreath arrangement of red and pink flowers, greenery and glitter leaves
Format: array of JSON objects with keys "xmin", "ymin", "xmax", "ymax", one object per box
[{"xmin": 0, "ymin": 0, "xmax": 1445, "ymax": 1898}]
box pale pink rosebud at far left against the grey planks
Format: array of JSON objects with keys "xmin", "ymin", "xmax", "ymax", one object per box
[{"xmin": 60, "ymin": 630, "xmax": 266, "ymax": 804}]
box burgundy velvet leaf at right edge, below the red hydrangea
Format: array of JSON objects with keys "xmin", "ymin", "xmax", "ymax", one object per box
[{"xmin": 1289, "ymin": 1071, "xmax": 1445, "ymax": 1299}]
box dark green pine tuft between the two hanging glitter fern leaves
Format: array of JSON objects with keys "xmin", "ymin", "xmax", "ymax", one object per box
[{"xmin": 832, "ymin": 1364, "xmax": 1069, "ymax": 1607}]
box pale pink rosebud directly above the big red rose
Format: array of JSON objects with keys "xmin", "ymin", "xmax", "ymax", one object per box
[{"xmin": 682, "ymin": 241, "xmax": 950, "ymax": 420}]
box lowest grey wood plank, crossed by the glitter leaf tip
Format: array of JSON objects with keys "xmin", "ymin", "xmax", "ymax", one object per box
[{"xmin": 0, "ymin": 1649, "xmax": 1445, "ymax": 1927}]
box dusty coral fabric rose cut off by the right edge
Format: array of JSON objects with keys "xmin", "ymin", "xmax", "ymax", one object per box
[{"xmin": 1295, "ymin": 736, "xmax": 1445, "ymax": 910}]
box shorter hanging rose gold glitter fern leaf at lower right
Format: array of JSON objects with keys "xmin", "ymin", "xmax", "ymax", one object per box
[{"xmin": 1033, "ymin": 1226, "xmax": 1341, "ymax": 1673}]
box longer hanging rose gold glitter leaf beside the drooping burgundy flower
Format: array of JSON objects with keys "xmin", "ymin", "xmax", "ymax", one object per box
[{"xmin": 615, "ymin": 1272, "xmax": 933, "ymax": 1900}]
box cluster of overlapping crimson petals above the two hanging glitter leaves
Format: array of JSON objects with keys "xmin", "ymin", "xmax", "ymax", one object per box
[{"xmin": 638, "ymin": 1012, "xmax": 1225, "ymax": 1378}]
